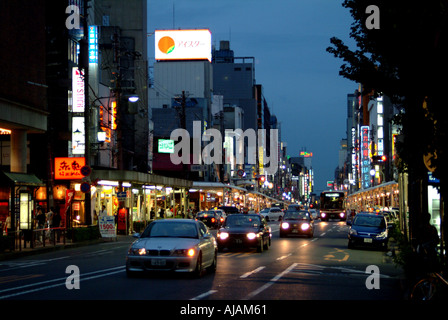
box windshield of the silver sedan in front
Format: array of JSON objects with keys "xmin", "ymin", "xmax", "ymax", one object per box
[{"xmin": 141, "ymin": 222, "xmax": 198, "ymax": 239}]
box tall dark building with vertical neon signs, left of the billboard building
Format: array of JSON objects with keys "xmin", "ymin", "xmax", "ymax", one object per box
[{"xmin": 89, "ymin": 0, "xmax": 150, "ymax": 172}]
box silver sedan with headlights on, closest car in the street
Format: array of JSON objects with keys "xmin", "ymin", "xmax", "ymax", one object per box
[{"xmin": 126, "ymin": 219, "xmax": 218, "ymax": 276}]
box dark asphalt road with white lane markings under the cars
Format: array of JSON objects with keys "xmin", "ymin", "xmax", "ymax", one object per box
[{"xmin": 0, "ymin": 221, "xmax": 403, "ymax": 308}]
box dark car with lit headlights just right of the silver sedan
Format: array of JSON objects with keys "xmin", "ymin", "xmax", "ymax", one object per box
[{"xmin": 217, "ymin": 214, "xmax": 272, "ymax": 252}]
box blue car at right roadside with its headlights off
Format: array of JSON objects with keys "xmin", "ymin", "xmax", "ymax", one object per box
[{"xmin": 347, "ymin": 212, "xmax": 389, "ymax": 250}]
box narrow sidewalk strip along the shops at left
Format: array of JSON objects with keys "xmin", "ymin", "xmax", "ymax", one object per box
[{"xmin": 0, "ymin": 235, "xmax": 132, "ymax": 261}]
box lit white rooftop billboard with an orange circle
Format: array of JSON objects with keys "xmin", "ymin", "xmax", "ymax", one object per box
[{"xmin": 154, "ymin": 29, "xmax": 212, "ymax": 62}]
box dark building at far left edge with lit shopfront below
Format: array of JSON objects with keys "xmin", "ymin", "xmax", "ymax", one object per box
[{"xmin": 0, "ymin": 0, "xmax": 48, "ymax": 231}]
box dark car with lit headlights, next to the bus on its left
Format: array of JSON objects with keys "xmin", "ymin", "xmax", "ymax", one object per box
[{"xmin": 280, "ymin": 210, "xmax": 314, "ymax": 238}]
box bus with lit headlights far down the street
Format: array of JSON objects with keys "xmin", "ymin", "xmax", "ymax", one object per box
[{"xmin": 320, "ymin": 191, "xmax": 347, "ymax": 221}]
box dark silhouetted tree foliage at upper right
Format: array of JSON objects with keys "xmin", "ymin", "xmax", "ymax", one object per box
[{"xmin": 327, "ymin": 0, "xmax": 448, "ymax": 178}]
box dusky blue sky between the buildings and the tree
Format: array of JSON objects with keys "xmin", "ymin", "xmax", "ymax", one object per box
[{"xmin": 148, "ymin": 0, "xmax": 357, "ymax": 192}]
